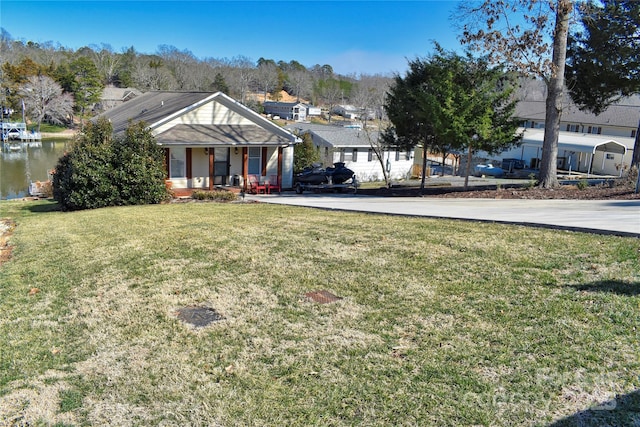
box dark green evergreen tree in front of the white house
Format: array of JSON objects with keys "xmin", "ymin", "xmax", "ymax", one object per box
[{"xmin": 384, "ymin": 46, "xmax": 520, "ymax": 190}]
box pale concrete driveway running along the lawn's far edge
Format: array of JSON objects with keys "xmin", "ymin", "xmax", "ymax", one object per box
[{"xmin": 247, "ymin": 192, "xmax": 640, "ymax": 237}]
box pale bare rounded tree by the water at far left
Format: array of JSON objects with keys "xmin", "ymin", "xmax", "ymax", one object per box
[{"xmin": 19, "ymin": 75, "xmax": 73, "ymax": 131}]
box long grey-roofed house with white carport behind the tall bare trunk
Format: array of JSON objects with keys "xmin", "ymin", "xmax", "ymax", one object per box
[{"xmin": 476, "ymin": 82, "xmax": 640, "ymax": 176}]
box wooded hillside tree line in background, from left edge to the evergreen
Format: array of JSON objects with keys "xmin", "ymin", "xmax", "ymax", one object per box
[{"xmin": 0, "ymin": 29, "xmax": 392, "ymax": 130}]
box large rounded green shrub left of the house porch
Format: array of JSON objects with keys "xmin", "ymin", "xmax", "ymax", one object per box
[{"xmin": 53, "ymin": 119, "xmax": 167, "ymax": 210}]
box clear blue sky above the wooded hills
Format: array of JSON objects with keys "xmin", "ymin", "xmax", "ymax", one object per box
[{"xmin": 0, "ymin": 0, "xmax": 461, "ymax": 75}]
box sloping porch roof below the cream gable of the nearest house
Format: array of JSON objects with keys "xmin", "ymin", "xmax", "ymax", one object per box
[{"xmin": 156, "ymin": 124, "xmax": 292, "ymax": 147}]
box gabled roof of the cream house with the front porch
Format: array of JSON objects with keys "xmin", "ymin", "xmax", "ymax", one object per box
[{"xmin": 99, "ymin": 91, "xmax": 298, "ymax": 145}]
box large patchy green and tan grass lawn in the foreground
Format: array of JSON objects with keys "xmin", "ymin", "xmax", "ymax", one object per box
[{"xmin": 0, "ymin": 201, "xmax": 640, "ymax": 426}]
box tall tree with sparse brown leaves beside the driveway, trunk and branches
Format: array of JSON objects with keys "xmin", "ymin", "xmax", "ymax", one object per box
[{"xmin": 458, "ymin": 0, "xmax": 573, "ymax": 188}]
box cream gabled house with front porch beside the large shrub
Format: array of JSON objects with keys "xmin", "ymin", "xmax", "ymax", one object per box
[{"xmin": 101, "ymin": 92, "xmax": 300, "ymax": 189}]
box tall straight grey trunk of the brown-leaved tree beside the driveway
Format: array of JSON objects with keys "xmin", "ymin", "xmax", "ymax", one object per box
[{"xmin": 539, "ymin": 0, "xmax": 573, "ymax": 188}]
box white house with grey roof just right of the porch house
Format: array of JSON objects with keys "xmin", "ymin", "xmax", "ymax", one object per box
[{"xmin": 287, "ymin": 123, "xmax": 414, "ymax": 181}]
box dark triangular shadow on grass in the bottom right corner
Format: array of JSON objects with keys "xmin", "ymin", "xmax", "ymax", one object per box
[{"xmin": 548, "ymin": 390, "xmax": 640, "ymax": 427}]
